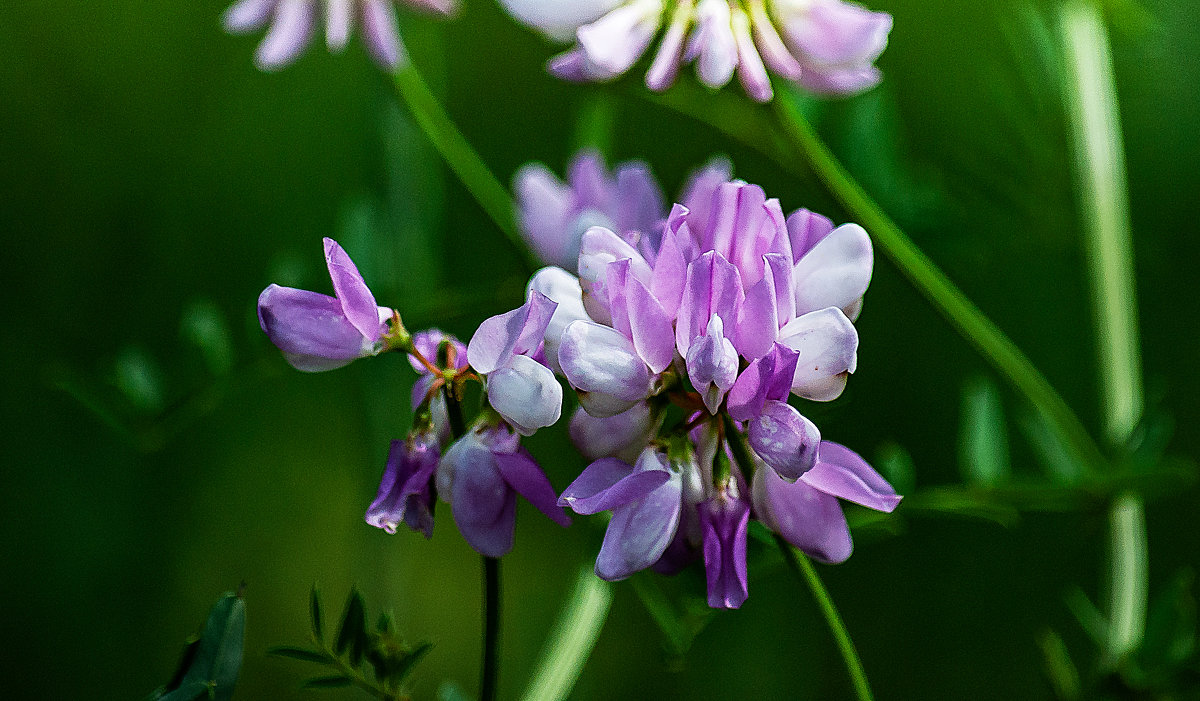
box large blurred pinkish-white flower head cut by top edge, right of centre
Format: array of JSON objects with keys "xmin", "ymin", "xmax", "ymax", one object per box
[{"xmin": 503, "ymin": 0, "xmax": 892, "ymax": 102}]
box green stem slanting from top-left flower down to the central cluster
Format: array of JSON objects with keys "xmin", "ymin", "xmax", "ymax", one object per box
[{"xmin": 392, "ymin": 60, "xmax": 540, "ymax": 270}]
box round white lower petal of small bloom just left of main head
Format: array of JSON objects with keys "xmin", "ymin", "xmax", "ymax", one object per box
[{"xmin": 487, "ymin": 355, "xmax": 563, "ymax": 436}]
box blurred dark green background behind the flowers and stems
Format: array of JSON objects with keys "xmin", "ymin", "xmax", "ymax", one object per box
[{"xmin": 0, "ymin": 0, "xmax": 1200, "ymax": 699}]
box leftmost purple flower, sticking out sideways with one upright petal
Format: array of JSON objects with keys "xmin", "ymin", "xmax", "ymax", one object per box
[{"xmin": 258, "ymin": 239, "xmax": 395, "ymax": 372}]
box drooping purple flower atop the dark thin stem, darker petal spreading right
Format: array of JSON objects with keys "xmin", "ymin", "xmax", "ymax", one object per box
[{"xmin": 436, "ymin": 424, "xmax": 571, "ymax": 557}]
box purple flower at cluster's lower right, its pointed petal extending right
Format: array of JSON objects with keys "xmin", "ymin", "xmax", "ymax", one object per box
[{"xmin": 752, "ymin": 441, "xmax": 901, "ymax": 563}]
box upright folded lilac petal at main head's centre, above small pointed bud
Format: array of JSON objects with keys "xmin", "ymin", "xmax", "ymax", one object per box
[{"xmin": 676, "ymin": 251, "xmax": 745, "ymax": 357}]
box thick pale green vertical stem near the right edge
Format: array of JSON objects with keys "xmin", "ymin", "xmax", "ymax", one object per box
[{"xmin": 1058, "ymin": 0, "xmax": 1150, "ymax": 666}]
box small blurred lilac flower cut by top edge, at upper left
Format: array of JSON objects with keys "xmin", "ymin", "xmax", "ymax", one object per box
[{"xmin": 222, "ymin": 0, "xmax": 457, "ymax": 71}]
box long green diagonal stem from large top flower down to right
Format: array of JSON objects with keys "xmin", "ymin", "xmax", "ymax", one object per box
[{"xmin": 774, "ymin": 98, "xmax": 1106, "ymax": 469}]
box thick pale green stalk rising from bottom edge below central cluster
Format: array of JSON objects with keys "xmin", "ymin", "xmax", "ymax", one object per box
[{"xmin": 522, "ymin": 568, "xmax": 612, "ymax": 701}]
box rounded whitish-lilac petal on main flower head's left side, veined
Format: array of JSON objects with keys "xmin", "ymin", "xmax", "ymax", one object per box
[{"xmin": 558, "ymin": 322, "xmax": 650, "ymax": 415}]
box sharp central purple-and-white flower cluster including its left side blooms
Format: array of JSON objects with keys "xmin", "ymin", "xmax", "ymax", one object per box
[{"xmin": 259, "ymin": 159, "xmax": 900, "ymax": 607}]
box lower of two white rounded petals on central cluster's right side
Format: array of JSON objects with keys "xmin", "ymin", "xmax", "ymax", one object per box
[{"xmin": 779, "ymin": 307, "xmax": 858, "ymax": 402}]
